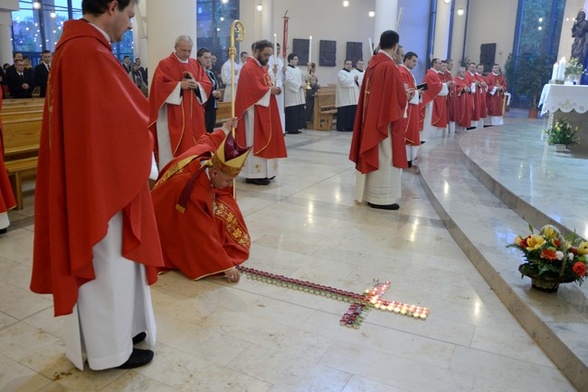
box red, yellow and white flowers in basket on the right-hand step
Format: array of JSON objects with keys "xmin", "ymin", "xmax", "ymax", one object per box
[{"xmin": 508, "ymin": 225, "xmax": 588, "ymax": 284}]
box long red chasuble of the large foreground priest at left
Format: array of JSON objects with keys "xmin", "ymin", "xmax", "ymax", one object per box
[{"xmin": 31, "ymin": 20, "xmax": 163, "ymax": 316}]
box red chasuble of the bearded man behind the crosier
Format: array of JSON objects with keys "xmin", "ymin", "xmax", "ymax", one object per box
[{"xmin": 235, "ymin": 57, "xmax": 288, "ymax": 159}]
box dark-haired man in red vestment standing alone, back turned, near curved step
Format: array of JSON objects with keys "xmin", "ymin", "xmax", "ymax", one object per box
[{"xmin": 349, "ymin": 30, "xmax": 408, "ymax": 210}]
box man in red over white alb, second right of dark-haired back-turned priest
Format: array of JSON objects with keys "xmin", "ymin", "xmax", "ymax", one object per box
[{"xmin": 420, "ymin": 58, "xmax": 449, "ymax": 133}]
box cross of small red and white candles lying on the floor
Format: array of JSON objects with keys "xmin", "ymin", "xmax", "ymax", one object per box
[{"xmin": 237, "ymin": 266, "xmax": 429, "ymax": 329}]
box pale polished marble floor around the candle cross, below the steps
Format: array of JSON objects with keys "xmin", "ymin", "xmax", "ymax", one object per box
[{"xmin": 0, "ymin": 115, "xmax": 576, "ymax": 392}]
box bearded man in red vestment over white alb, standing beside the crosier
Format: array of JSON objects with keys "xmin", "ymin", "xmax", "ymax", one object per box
[{"xmin": 235, "ymin": 40, "xmax": 288, "ymax": 185}]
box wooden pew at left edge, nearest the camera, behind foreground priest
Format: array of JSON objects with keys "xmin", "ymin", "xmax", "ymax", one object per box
[{"xmin": 2, "ymin": 113, "xmax": 43, "ymax": 210}]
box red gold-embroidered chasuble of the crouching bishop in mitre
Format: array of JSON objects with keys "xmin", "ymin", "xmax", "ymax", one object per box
[{"xmin": 152, "ymin": 129, "xmax": 251, "ymax": 279}]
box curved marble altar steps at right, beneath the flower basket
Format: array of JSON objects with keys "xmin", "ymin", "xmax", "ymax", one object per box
[{"xmin": 419, "ymin": 125, "xmax": 588, "ymax": 390}]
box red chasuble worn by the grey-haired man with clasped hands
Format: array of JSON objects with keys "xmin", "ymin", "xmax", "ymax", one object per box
[{"xmin": 149, "ymin": 53, "xmax": 212, "ymax": 161}]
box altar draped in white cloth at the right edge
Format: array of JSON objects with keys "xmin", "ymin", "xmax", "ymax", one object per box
[{"xmin": 539, "ymin": 84, "xmax": 588, "ymax": 152}]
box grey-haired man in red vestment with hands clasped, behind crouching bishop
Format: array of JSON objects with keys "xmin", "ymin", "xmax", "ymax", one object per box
[{"xmin": 149, "ymin": 35, "xmax": 214, "ymax": 169}]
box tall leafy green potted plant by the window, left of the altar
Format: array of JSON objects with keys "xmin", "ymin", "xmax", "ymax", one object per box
[{"xmin": 515, "ymin": 55, "xmax": 553, "ymax": 118}]
